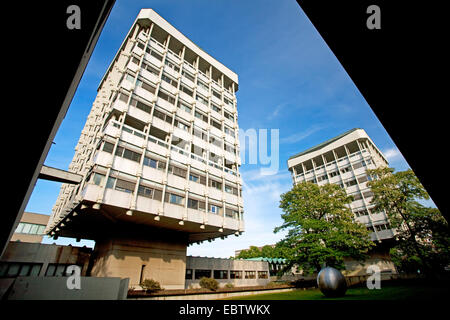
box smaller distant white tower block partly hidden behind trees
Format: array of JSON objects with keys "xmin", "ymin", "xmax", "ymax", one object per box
[{"xmin": 288, "ymin": 128, "xmax": 394, "ymax": 242}]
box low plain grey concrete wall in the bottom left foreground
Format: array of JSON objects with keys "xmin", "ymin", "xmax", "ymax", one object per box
[{"xmin": 8, "ymin": 277, "xmax": 129, "ymax": 300}]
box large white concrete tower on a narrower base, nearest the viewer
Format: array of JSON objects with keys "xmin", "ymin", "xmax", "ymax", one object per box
[{"xmin": 46, "ymin": 9, "xmax": 244, "ymax": 288}]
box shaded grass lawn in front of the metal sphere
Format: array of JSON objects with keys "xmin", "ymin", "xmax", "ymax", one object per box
[{"xmin": 226, "ymin": 284, "xmax": 450, "ymax": 300}]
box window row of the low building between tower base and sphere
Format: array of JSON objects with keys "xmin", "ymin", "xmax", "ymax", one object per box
[{"xmin": 186, "ymin": 269, "xmax": 268, "ymax": 280}]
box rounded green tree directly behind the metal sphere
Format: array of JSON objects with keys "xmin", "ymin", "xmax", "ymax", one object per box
[{"xmin": 274, "ymin": 182, "xmax": 374, "ymax": 273}]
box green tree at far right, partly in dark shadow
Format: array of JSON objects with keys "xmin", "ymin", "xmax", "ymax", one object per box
[{"xmin": 368, "ymin": 168, "xmax": 450, "ymax": 276}]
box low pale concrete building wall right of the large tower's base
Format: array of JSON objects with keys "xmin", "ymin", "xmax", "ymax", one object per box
[{"xmin": 186, "ymin": 256, "xmax": 270, "ymax": 288}]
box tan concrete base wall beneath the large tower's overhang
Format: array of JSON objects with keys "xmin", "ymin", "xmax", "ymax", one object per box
[{"xmin": 91, "ymin": 239, "xmax": 187, "ymax": 289}]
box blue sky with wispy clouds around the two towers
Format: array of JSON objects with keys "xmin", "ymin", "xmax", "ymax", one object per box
[{"xmin": 26, "ymin": 0, "xmax": 416, "ymax": 257}]
